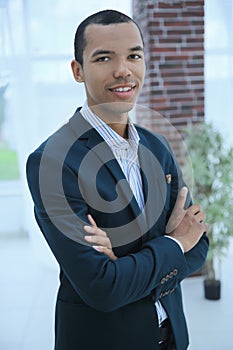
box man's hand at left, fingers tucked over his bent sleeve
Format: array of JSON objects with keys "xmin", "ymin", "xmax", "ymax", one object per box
[{"xmin": 84, "ymin": 214, "xmax": 117, "ymax": 260}]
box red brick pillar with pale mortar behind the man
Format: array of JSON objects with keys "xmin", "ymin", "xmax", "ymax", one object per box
[{"xmin": 133, "ymin": 0, "xmax": 204, "ymax": 161}]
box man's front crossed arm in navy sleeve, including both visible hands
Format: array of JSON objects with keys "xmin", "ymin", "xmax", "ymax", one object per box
[{"xmin": 27, "ymin": 152, "xmax": 208, "ymax": 312}]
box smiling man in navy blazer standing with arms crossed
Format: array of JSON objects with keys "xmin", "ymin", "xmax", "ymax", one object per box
[{"xmin": 27, "ymin": 10, "xmax": 208, "ymax": 350}]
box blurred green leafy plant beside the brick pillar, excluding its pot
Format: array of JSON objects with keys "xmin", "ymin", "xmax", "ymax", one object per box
[{"xmin": 184, "ymin": 123, "xmax": 233, "ymax": 279}]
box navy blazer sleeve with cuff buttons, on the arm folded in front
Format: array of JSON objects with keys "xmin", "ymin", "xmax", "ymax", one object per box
[{"xmin": 27, "ymin": 151, "xmax": 204, "ymax": 312}]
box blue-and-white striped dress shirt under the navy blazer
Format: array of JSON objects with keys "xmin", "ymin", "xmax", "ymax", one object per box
[{"xmin": 80, "ymin": 103, "xmax": 167, "ymax": 324}]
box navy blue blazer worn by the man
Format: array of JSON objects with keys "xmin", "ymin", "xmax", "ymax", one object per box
[{"xmin": 27, "ymin": 111, "xmax": 208, "ymax": 350}]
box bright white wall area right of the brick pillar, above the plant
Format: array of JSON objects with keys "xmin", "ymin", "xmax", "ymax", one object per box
[{"xmin": 205, "ymin": 0, "xmax": 233, "ymax": 146}]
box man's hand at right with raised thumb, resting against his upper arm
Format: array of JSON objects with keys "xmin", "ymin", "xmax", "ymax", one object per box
[{"xmin": 166, "ymin": 187, "xmax": 209, "ymax": 253}]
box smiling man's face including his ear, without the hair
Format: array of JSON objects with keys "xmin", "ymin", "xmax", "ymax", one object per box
[{"xmin": 72, "ymin": 22, "xmax": 145, "ymax": 118}]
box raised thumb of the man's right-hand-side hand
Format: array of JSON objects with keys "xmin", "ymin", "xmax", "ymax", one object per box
[{"xmin": 166, "ymin": 187, "xmax": 188, "ymax": 234}]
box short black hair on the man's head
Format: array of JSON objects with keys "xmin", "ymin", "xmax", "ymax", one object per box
[{"xmin": 74, "ymin": 10, "xmax": 143, "ymax": 66}]
